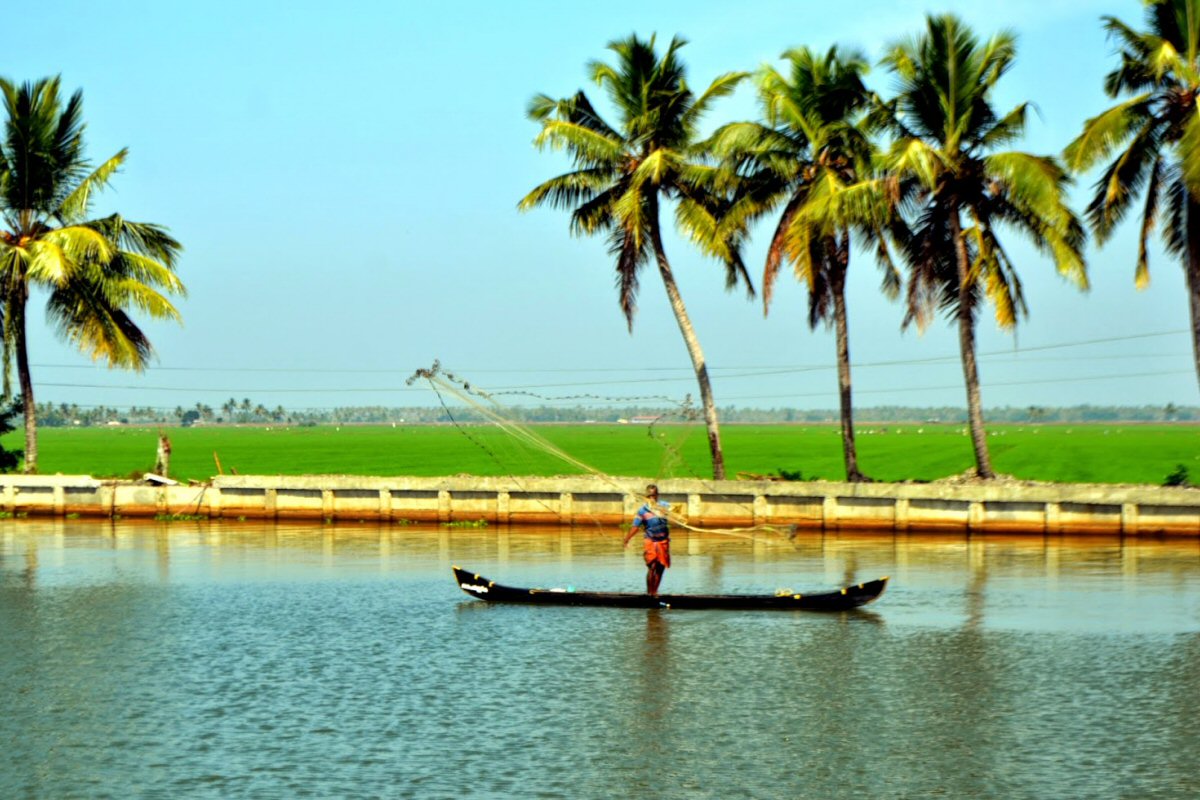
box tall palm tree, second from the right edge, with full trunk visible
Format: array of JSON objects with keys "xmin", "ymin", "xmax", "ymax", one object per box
[{"xmin": 876, "ymin": 14, "xmax": 1087, "ymax": 477}]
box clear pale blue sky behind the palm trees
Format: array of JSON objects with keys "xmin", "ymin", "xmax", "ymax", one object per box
[{"xmin": 0, "ymin": 0, "xmax": 1200, "ymax": 408}]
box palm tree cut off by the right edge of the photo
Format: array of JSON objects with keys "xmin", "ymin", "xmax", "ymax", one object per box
[{"xmin": 1064, "ymin": 0, "xmax": 1200, "ymax": 393}]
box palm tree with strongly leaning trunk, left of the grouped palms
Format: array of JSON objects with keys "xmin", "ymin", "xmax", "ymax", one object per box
[{"xmin": 518, "ymin": 35, "xmax": 752, "ymax": 479}]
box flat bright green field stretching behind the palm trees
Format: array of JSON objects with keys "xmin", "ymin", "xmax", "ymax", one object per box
[{"xmin": 0, "ymin": 425, "xmax": 1200, "ymax": 485}]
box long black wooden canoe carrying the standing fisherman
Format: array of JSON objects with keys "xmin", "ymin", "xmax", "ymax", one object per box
[{"xmin": 454, "ymin": 566, "xmax": 888, "ymax": 612}]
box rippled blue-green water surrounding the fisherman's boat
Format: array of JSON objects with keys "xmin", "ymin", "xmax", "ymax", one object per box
[{"xmin": 0, "ymin": 521, "xmax": 1200, "ymax": 799}]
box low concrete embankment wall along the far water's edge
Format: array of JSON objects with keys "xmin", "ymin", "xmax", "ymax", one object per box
[{"xmin": 0, "ymin": 475, "xmax": 1200, "ymax": 536}]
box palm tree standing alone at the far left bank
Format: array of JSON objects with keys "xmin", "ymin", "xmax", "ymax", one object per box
[{"xmin": 0, "ymin": 78, "xmax": 185, "ymax": 473}]
